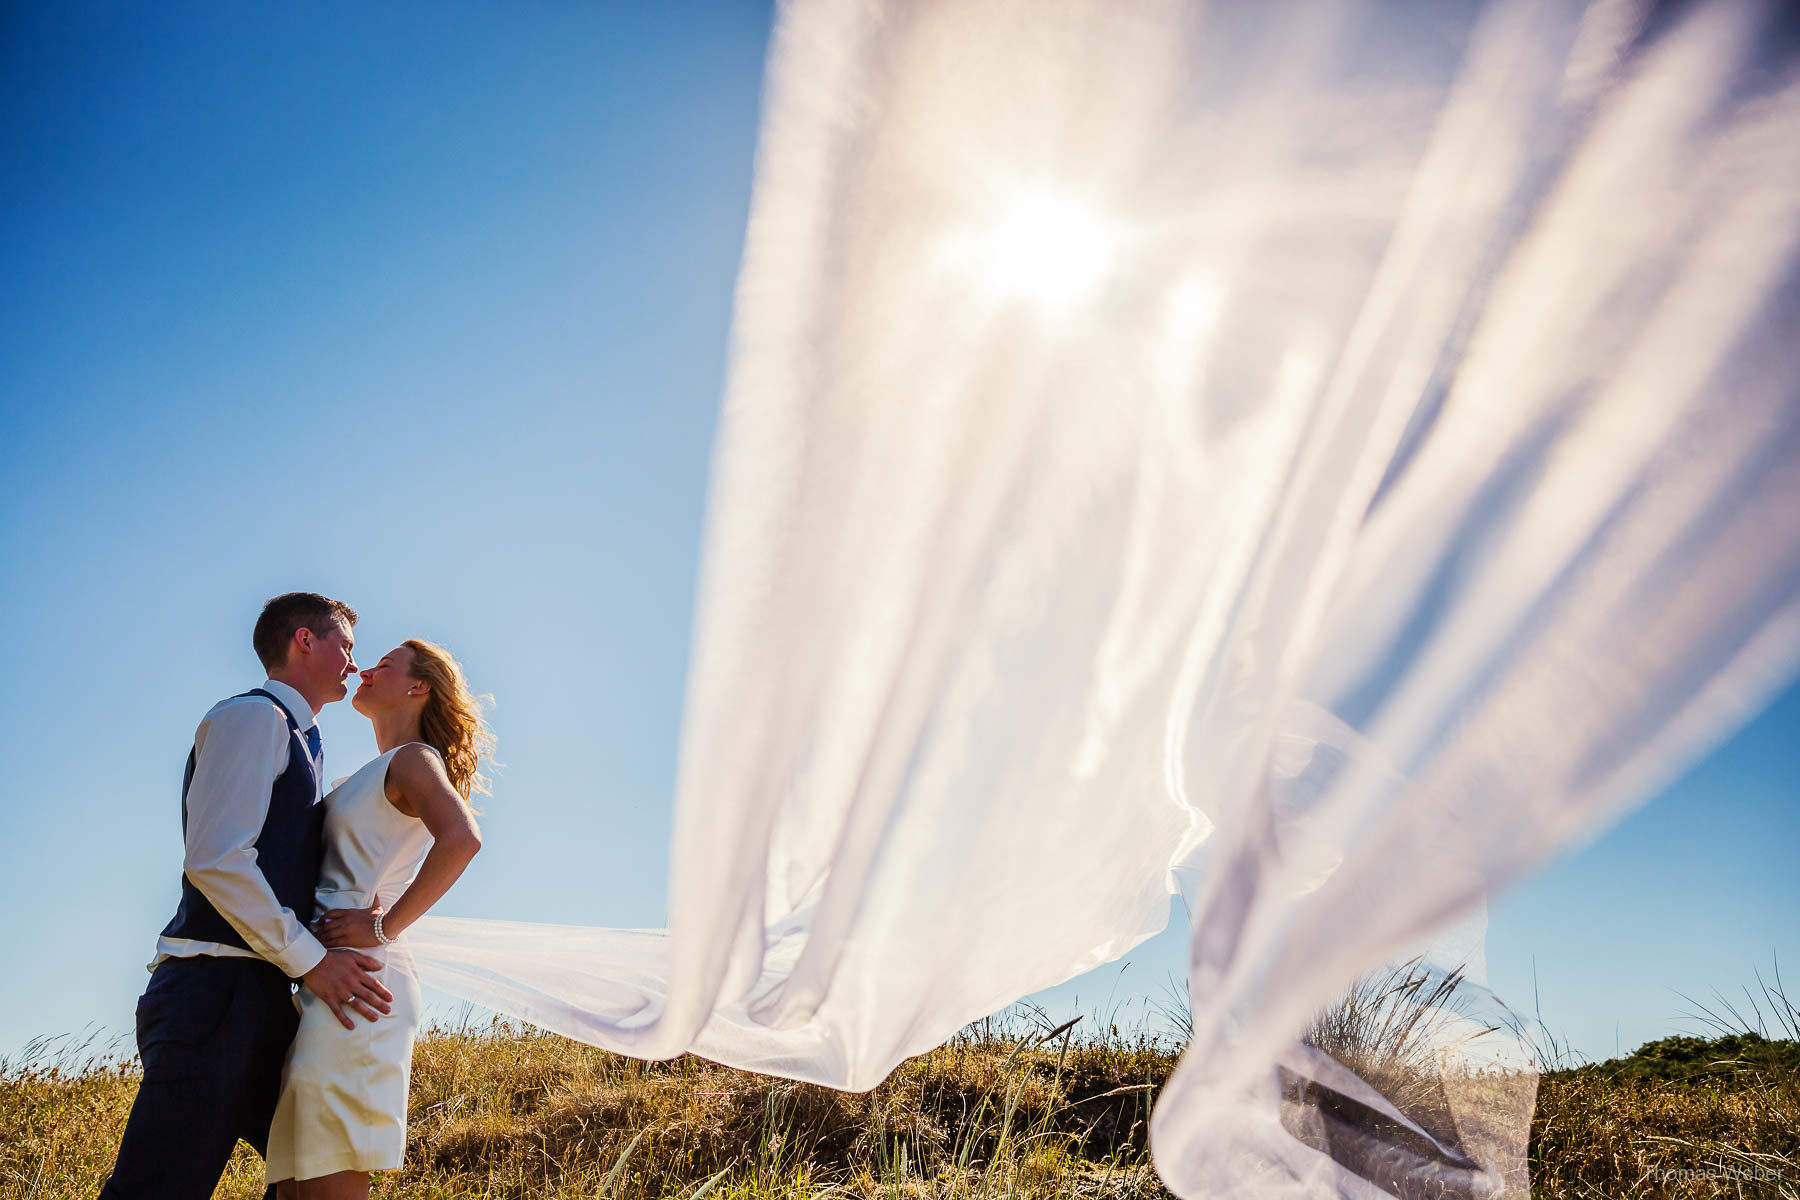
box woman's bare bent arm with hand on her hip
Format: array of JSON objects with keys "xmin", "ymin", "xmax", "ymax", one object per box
[{"xmin": 319, "ymin": 745, "xmax": 481, "ymax": 946}]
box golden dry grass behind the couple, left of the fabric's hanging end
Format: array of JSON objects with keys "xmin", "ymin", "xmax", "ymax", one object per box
[{"xmin": 0, "ymin": 1022, "xmax": 1175, "ymax": 1200}]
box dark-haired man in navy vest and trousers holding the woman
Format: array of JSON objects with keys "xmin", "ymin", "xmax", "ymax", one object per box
[{"xmin": 101, "ymin": 592, "xmax": 394, "ymax": 1200}]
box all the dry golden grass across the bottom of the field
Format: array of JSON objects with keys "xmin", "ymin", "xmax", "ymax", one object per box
[{"xmin": 0, "ymin": 978, "xmax": 1800, "ymax": 1200}]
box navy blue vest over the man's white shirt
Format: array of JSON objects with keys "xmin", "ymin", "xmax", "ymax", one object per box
[{"xmin": 162, "ymin": 687, "xmax": 326, "ymax": 971}]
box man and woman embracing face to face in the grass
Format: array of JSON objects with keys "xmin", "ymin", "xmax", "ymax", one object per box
[{"xmin": 101, "ymin": 592, "xmax": 493, "ymax": 1200}]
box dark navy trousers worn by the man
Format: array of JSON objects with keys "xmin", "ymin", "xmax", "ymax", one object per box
[{"xmin": 101, "ymin": 955, "xmax": 301, "ymax": 1200}]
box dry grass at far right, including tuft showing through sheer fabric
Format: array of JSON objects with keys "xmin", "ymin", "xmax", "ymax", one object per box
[{"xmin": 1305, "ymin": 961, "xmax": 1800, "ymax": 1200}]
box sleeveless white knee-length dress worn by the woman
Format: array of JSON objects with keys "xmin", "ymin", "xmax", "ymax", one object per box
[{"xmin": 265, "ymin": 743, "xmax": 432, "ymax": 1180}]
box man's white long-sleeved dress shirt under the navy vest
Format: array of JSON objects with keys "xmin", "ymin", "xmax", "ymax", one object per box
[{"xmin": 149, "ymin": 680, "xmax": 326, "ymax": 979}]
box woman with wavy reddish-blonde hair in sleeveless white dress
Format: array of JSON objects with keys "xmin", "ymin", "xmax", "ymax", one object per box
[{"xmin": 266, "ymin": 639, "xmax": 493, "ymax": 1200}]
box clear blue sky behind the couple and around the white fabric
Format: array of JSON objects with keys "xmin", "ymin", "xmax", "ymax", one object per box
[{"xmin": 0, "ymin": 0, "xmax": 1800, "ymax": 1056}]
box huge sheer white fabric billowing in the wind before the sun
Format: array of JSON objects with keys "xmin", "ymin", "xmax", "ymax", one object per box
[{"xmin": 409, "ymin": 0, "xmax": 1800, "ymax": 1196}]
